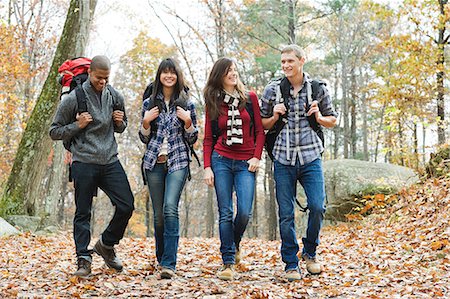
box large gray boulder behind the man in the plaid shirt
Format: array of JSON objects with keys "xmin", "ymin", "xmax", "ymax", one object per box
[{"xmin": 323, "ymin": 159, "xmax": 419, "ymax": 220}]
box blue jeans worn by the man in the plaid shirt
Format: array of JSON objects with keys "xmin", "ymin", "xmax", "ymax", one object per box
[{"xmin": 274, "ymin": 158, "xmax": 325, "ymax": 271}]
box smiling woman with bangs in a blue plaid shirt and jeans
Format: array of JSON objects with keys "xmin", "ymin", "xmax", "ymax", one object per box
[{"xmin": 139, "ymin": 58, "xmax": 198, "ymax": 278}]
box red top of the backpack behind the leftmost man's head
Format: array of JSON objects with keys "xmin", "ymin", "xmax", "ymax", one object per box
[{"xmin": 58, "ymin": 57, "xmax": 92, "ymax": 94}]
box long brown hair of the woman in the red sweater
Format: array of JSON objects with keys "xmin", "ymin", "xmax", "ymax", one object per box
[{"xmin": 203, "ymin": 57, "xmax": 247, "ymax": 119}]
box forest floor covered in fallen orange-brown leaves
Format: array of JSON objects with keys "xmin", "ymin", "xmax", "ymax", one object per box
[{"xmin": 0, "ymin": 179, "xmax": 450, "ymax": 299}]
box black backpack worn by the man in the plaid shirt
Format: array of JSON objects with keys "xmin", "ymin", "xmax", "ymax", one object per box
[{"xmin": 264, "ymin": 77, "xmax": 325, "ymax": 161}]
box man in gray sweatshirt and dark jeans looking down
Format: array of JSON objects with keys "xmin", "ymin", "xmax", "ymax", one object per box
[{"xmin": 50, "ymin": 56, "xmax": 134, "ymax": 277}]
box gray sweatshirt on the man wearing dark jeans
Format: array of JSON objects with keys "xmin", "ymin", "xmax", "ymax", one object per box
[{"xmin": 49, "ymin": 79, "xmax": 127, "ymax": 165}]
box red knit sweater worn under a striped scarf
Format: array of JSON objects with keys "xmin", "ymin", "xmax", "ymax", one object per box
[{"xmin": 203, "ymin": 92, "xmax": 266, "ymax": 168}]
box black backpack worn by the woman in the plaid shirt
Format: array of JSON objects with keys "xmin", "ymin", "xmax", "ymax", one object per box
[{"xmin": 141, "ymin": 82, "xmax": 201, "ymax": 185}]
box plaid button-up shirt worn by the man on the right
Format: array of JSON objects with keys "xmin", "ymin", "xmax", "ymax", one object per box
[{"xmin": 260, "ymin": 73, "xmax": 337, "ymax": 166}]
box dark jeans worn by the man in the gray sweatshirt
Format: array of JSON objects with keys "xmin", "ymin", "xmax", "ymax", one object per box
[{"xmin": 72, "ymin": 161, "xmax": 134, "ymax": 260}]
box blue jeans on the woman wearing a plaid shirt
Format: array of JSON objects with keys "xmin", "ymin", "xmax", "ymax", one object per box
[{"xmin": 145, "ymin": 163, "xmax": 188, "ymax": 270}]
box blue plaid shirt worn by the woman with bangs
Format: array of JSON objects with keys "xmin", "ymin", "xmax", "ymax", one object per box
[{"xmin": 139, "ymin": 94, "xmax": 198, "ymax": 173}]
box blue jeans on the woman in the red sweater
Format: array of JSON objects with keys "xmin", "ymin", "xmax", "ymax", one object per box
[{"xmin": 211, "ymin": 151, "xmax": 255, "ymax": 265}]
